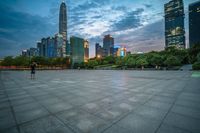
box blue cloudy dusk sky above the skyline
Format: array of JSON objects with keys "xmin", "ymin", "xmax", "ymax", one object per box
[{"xmin": 0, "ymin": 0, "xmax": 198, "ymax": 57}]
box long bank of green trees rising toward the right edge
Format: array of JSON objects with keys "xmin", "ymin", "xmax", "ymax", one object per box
[{"xmin": 77, "ymin": 45, "xmax": 200, "ymax": 69}]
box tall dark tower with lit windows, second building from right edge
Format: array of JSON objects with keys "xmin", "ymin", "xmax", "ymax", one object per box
[{"xmin": 164, "ymin": 0, "xmax": 185, "ymax": 48}]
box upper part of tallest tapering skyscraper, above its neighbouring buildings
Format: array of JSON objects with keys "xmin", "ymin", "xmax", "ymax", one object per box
[{"xmin": 59, "ymin": 2, "xmax": 67, "ymax": 40}]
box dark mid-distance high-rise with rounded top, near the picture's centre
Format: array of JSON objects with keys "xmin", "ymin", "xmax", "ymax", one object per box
[{"xmin": 103, "ymin": 35, "xmax": 114, "ymax": 56}]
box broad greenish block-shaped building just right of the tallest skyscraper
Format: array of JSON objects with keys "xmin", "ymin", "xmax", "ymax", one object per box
[{"xmin": 70, "ymin": 36, "xmax": 85, "ymax": 66}]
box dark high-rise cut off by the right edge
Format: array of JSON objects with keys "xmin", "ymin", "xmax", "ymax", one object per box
[{"xmin": 189, "ymin": 1, "xmax": 200, "ymax": 48}]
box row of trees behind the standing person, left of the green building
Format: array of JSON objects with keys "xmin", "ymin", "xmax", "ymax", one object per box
[{"xmin": 0, "ymin": 56, "xmax": 69, "ymax": 67}]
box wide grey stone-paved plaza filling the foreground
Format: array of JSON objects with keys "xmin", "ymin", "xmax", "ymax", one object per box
[{"xmin": 0, "ymin": 70, "xmax": 200, "ymax": 133}]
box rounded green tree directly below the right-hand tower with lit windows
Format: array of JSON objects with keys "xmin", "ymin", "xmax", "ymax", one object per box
[{"xmin": 164, "ymin": 55, "xmax": 181, "ymax": 67}]
